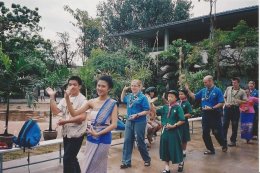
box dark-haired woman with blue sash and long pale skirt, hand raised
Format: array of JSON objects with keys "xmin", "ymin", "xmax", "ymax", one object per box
[{"xmin": 65, "ymin": 76, "xmax": 117, "ymax": 173}]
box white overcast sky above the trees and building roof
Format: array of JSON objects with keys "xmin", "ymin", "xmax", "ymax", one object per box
[{"xmin": 3, "ymin": 0, "xmax": 258, "ymax": 40}]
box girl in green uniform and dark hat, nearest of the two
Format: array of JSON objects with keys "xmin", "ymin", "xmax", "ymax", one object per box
[{"xmin": 156, "ymin": 90, "xmax": 185, "ymax": 173}]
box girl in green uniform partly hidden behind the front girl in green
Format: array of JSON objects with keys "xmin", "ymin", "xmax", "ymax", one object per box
[{"xmin": 178, "ymin": 89, "xmax": 192, "ymax": 157}]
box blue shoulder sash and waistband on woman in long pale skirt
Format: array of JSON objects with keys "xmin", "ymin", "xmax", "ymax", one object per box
[{"xmin": 87, "ymin": 98, "xmax": 116, "ymax": 144}]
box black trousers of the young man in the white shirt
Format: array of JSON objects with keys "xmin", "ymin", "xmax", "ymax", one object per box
[{"xmin": 63, "ymin": 136, "xmax": 84, "ymax": 173}]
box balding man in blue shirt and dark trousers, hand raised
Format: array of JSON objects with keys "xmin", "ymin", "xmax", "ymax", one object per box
[{"xmin": 186, "ymin": 75, "xmax": 227, "ymax": 155}]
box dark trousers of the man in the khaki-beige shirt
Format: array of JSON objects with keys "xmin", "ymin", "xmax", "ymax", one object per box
[{"xmin": 223, "ymin": 106, "xmax": 240, "ymax": 143}]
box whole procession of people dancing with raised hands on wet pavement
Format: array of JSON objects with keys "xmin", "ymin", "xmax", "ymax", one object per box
[{"xmin": 46, "ymin": 75, "xmax": 258, "ymax": 173}]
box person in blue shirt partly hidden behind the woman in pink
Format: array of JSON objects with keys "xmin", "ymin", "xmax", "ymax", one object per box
[{"xmin": 248, "ymin": 81, "xmax": 258, "ymax": 140}]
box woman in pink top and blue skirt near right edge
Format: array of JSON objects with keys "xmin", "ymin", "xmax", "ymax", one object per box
[{"xmin": 239, "ymin": 89, "xmax": 258, "ymax": 143}]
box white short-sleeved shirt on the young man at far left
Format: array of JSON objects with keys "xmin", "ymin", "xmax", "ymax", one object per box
[{"xmin": 57, "ymin": 93, "xmax": 87, "ymax": 138}]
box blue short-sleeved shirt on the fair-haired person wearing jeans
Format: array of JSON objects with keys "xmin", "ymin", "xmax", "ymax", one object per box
[{"xmin": 123, "ymin": 92, "xmax": 150, "ymax": 122}]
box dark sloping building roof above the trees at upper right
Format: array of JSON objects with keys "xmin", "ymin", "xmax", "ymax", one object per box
[{"xmin": 111, "ymin": 6, "xmax": 259, "ymax": 42}]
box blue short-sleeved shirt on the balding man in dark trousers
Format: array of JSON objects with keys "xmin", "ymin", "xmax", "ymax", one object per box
[{"xmin": 195, "ymin": 86, "xmax": 224, "ymax": 108}]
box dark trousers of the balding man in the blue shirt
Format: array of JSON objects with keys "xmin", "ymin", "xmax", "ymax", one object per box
[{"xmin": 202, "ymin": 110, "xmax": 226, "ymax": 151}]
